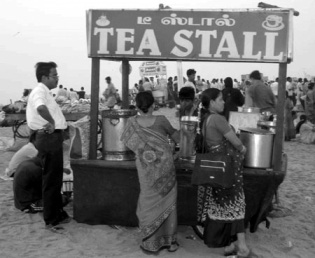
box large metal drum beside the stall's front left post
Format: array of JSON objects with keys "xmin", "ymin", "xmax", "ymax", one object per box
[{"xmin": 102, "ymin": 109, "xmax": 137, "ymax": 161}]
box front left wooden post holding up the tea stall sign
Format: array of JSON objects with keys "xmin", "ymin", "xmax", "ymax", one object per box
[{"xmin": 89, "ymin": 58, "xmax": 100, "ymax": 160}]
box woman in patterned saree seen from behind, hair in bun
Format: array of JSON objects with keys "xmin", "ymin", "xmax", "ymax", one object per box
[{"xmin": 121, "ymin": 92, "xmax": 179, "ymax": 254}]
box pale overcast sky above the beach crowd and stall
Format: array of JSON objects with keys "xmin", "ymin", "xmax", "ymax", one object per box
[{"xmin": 0, "ymin": 0, "xmax": 315, "ymax": 104}]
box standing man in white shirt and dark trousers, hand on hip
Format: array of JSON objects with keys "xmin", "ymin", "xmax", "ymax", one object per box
[{"xmin": 26, "ymin": 62, "xmax": 70, "ymax": 232}]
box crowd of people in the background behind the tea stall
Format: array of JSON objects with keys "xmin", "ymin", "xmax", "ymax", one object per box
[{"xmin": 130, "ymin": 69, "xmax": 315, "ymax": 143}]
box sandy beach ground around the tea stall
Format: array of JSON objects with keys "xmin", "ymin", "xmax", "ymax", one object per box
[{"xmin": 0, "ymin": 108, "xmax": 315, "ymax": 258}]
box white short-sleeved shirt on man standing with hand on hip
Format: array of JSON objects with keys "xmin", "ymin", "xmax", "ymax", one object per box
[{"xmin": 26, "ymin": 82, "xmax": 67, "ymax": 130}]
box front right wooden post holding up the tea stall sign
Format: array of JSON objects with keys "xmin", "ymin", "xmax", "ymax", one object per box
[{"xmin": 273, "ymin": 63, "xmax": 287, "ymax": 171}]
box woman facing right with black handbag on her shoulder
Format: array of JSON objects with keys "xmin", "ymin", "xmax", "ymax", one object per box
[{"xmin": 197, "ymin": 88, "xmax": 250, "ymax": 257}]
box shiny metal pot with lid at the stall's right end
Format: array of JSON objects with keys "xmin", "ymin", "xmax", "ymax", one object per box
[{"xmin": 240, "ymin": 127, "xmax": 274, "ymax": 168}]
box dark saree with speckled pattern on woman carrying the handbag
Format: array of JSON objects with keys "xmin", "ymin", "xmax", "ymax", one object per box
[{"xmin": 197, "ymin": 140, "xmax": 245, "ymax": 247}]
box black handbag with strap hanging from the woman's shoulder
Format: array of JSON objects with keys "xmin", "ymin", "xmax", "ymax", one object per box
[{"xmin": 191, "ymin": 117, "xmax": 235, "ymax": 188}]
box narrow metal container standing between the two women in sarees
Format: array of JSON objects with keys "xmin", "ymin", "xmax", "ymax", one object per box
[{"xmin": 179, "ymin": 116, "xmax": 198, "ymax": 161}]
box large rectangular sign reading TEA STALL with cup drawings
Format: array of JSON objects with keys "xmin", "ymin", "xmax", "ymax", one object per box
[{"xmin": 87, "ymin": 9, "xmax": 293, "ymax": 63}]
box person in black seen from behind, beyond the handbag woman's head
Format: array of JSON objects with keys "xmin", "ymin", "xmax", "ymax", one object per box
[{"xmin": 222, "ymin": 77, "xmax": 244, "ymax": 121}]
